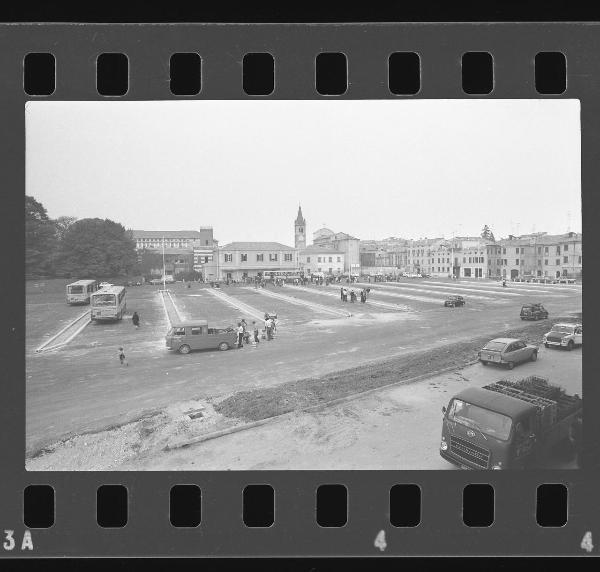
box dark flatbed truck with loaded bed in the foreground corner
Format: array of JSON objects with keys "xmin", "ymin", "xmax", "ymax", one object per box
[{"xmin": 440, "ymin": 376, "xmax": 582, "ymax": 470}]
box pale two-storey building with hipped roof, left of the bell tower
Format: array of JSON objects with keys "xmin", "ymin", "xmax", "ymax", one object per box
[{"xmin": 216, "ymin": 242, "xmax": 299, "ymax": 280}]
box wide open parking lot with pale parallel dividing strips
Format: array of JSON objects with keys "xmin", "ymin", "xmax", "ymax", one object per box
[{"xmin": 26, "ymin": 279, "xmax": 581, "ymax": 462}]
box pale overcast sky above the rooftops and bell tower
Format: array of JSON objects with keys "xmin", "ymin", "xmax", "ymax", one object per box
[{"xmin": 26, "ymin": 99, "xmax": 581, "ymax": 245}]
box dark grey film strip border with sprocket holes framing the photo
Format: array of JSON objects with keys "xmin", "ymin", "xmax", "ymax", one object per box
[{"xmin": 0, "ymin": 24, "xmax": 600, "ymax": 556}]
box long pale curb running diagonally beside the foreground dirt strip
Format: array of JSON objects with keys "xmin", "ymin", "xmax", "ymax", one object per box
[{"xmin": 163, "ymin": 360, "xmax": 479, "ymax": 451}]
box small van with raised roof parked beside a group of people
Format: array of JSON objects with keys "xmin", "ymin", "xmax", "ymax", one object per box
[{"xmin": 166, "ymin": 320, "xmax": 237, "ymax": 354}]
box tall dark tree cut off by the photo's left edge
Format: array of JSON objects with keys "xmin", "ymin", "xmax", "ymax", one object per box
[{"xmin": 25, "ymin": 196, "xmax": 56, "ymax": 278}]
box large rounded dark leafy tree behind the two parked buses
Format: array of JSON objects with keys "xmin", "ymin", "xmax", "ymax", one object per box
[{"xmin": 57, "ymin": 218, "xmax": 136, "ymax": 278}]
